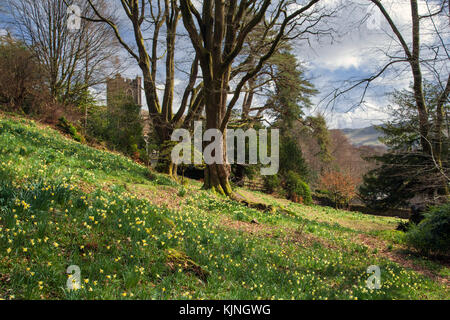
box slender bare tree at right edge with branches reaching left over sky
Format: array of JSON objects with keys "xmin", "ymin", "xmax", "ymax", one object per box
[{"xmin": 329, "ymin": 0, "xmax": 450, "ymax": 192}]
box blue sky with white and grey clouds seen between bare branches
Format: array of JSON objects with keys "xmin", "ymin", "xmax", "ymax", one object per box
[{"xmin": 0, "ymin": 0, "xmax": 450, "ymax": 128}]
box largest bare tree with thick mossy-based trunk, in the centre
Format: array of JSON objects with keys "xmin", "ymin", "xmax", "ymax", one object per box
[{"xmin": 180, "ymin": 0, "xmax": 326, "ymax": 195}]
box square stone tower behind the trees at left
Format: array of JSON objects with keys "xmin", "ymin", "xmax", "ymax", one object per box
[{"xmin": 106, "ymin": 74, "xmax": 142, "ymax": 107}]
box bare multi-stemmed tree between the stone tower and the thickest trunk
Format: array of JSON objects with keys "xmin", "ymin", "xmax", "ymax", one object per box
[{"xmin": 85, "ymin": 0, "xmax": 203, "ymax": 174}]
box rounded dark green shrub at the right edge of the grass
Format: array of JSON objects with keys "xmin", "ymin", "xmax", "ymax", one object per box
[{"xmin": 406, "ymin": 203, "xmax": 450, "ymax": 255}]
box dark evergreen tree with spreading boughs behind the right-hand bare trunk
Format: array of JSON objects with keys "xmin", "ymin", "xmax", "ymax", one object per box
[{"xmin": 360, "ymin": 83, "xmax": 450, "ymax": 208}]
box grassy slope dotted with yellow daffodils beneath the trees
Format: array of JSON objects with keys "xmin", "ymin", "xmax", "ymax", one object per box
[{"xmin": 0, "ymin": 115, "xmax": 450, "ymax": 299}]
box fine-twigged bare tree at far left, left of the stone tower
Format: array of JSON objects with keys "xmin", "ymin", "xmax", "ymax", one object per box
[{"xmin": 9, "ymin": 0, "xmax": 118, "ymax": 103}]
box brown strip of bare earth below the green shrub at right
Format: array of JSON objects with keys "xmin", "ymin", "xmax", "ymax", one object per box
[{"xmin": 358, "ymin": 234, "xmax": 450, "ymax": 287}]
